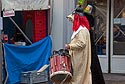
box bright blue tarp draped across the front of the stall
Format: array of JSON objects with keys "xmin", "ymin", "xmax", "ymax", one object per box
[{"xmin": 4, "ymin": 36, "xmax": 52, "ymax": 84}]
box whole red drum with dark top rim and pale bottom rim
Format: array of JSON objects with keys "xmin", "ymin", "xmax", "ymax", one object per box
[{"xmin": 50, "ymin": 49, "xmax": 72, "ymax": 82}]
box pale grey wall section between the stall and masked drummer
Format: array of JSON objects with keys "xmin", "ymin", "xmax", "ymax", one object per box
[{"xmin": 50, "ymin": 0, "xmax": 74, "ymax": 50}]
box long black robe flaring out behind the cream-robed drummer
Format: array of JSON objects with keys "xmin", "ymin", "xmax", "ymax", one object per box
[{"xmin": 90, "ymin": 30, "xmax": 105, "ymax": 84}]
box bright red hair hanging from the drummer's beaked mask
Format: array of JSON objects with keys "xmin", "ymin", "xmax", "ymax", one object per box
[{"xmin": 72, "ymin": 13, "xmax": 90, "ymax": 31}]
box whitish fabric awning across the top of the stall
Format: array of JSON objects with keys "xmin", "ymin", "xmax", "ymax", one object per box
[{"xmin": 1, "ymin": 0, "xmax": 49, "ymax": 10}]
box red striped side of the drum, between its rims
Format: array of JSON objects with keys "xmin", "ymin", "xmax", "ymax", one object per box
[{"xmin": 50, "ymin": 55, "xmax": 71, "ymax": 74}]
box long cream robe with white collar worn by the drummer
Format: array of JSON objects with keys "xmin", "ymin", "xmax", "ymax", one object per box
[{"xmin": 69, "ymin": 26, "xmax": 92, "ymax": 84}]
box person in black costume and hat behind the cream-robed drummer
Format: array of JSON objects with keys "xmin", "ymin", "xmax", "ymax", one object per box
[{"xmin": 84, "ymin": 4, "xmax": 105, "ymax": 84}]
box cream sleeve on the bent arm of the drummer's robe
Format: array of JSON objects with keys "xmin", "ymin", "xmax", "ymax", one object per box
[{"xmin": 69, "ymin": 29, "xmax": 90, "ymax": 50}]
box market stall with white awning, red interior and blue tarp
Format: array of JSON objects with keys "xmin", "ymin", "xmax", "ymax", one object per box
[{"xmin": 1, "ymin": 0, "xmax": 52, "ymax": 84}]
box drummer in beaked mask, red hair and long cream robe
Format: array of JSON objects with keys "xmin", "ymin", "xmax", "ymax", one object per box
[{"xmin": 65, "ymin": 7, "xmax": 92, "ymax": 84}]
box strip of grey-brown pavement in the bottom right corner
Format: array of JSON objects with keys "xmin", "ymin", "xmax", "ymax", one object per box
[{"xmin": 103, "ymin": 73, "xmax": 125, "ymax": 84}]
